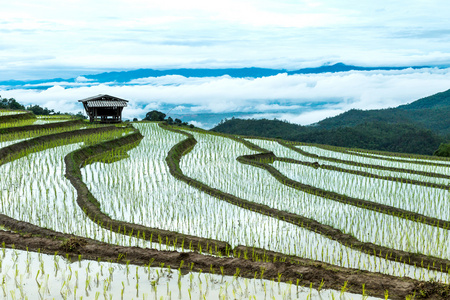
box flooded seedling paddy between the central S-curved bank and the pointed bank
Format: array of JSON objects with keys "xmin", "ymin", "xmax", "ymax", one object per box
[{"xmin": 182, "ymin": 133, "xmax": 450, "ymax": 266}]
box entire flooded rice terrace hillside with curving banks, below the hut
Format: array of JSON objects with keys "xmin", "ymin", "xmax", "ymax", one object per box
[{"xmin": 0, "ymin": 106, "xmax": 450, "ymax": 299}]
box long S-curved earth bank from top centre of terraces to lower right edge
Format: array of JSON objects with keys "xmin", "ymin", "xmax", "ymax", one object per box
[{"xmin": 160, "ymin": 124, "xmax": 450, "ymax": 272}]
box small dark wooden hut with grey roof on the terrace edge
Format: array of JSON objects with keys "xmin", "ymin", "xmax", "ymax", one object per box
[{"xmin": 78, "ymin": 94, "xmax": 128, "ymax": 123}]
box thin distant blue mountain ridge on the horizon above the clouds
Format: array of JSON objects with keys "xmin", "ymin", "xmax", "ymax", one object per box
[{"xmin": 0, "ymin": 63, "xmax": 429, "ymax": 86}]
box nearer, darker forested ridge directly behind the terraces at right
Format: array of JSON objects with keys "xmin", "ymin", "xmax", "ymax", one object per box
[{"xmin": 212, "ymin": 119, "xmax": 450, "ymax": 156}]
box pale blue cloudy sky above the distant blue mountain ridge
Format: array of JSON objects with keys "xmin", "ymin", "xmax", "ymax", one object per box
[{"xmin": 0, "ymin": 0, "xmax": 450, "ymax": 80}]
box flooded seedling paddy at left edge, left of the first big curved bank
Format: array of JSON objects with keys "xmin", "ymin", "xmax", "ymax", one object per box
[{"xmin": 0, "ymin": 132, "xmax": 168, "ymax": 246}]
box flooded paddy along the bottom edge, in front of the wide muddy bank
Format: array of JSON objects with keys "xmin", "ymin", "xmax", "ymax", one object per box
[{"xmin": 0, "ymin": 248, "xmax": 379, "ymax": 300}]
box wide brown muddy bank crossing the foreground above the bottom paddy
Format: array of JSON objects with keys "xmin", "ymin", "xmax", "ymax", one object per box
[{"xmin": 0, "ymin": 225, "xmax": 442, "ymax": 300}]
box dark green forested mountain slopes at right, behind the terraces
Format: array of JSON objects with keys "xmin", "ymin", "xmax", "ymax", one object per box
[{"xmin": 212, "ymin": 90, "xmax": 450, "ymax": 155}]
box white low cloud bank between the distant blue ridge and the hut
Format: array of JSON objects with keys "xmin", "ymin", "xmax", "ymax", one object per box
[{"xmin": 0, "ymin": 68, "xmax": 450, "ymax": 125}]
